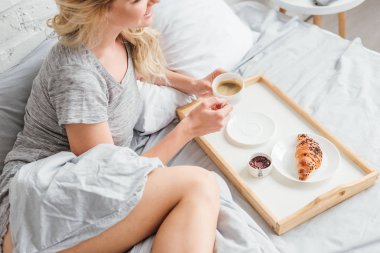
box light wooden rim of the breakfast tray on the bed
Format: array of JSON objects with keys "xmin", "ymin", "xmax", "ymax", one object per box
[{"xmin": 177, "ymin": 75, "xmax": 379, "ymax": 235}]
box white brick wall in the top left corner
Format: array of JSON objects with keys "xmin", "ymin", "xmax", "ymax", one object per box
[{"xmin": 0, "ymin": 0, "xmax": 56, "ymax": 73}]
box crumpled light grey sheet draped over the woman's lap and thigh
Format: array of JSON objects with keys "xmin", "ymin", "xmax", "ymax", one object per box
[{"xmin": 9, "ymin": 144, "xmax": 163, "ymax": 253}]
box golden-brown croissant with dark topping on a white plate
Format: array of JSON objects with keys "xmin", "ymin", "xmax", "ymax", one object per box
[{"xmin": 295, "ymin": 134, "xmax": 322, "ymax": 181}]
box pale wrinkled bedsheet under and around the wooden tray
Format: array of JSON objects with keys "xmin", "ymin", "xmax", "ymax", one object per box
[{"xmin": 135, "ymin": 2, "xmax": 380, "ymax": 253}]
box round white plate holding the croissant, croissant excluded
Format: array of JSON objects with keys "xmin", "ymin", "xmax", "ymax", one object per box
[{"xmin": 272, "ymin": 134, "xmax": 340, "ymax": 183}]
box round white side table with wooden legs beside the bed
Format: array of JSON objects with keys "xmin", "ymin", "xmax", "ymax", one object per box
[{"xmin": 274, "ymin": 0, "xmax": 365, "ymax": 38}]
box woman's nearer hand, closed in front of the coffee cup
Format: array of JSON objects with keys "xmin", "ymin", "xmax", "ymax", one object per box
[{"xmin": 182, "ymin": 97, "xmax": 232, "ymax": 138}]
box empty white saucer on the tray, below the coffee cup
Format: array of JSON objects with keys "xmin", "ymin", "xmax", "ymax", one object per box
[{"xmin": 226, "ymin": 112, "xmax": 276, "ymax": 146}]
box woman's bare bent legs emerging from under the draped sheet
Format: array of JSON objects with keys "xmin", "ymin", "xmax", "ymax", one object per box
[{"xmin": 62, "ymin": 166, "xmax": 219, "ymax": 253}]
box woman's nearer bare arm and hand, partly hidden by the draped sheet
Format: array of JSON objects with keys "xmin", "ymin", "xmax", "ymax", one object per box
[{"xmin": 65, "ymin": 97, "xmax": 232, "ymax": 163}]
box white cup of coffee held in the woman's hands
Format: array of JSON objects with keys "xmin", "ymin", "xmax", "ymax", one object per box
[{"xmin": 212, "ymin": 72, "xmax": 244, "ymax": 105}]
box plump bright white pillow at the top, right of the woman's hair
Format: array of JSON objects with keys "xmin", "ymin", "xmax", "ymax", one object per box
[{"xmin": 151, "ymin": 0, "xmax": 256, "ymax": 78}]
